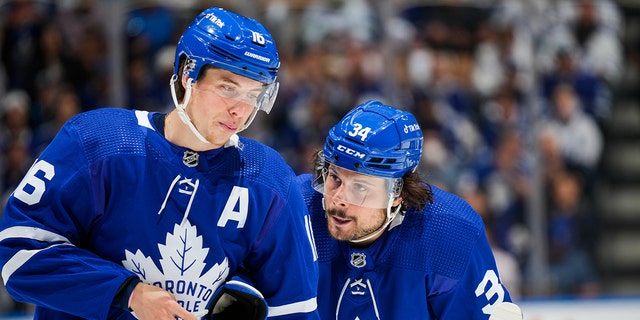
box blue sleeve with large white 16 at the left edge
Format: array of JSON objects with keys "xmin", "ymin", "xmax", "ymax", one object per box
[{"xmin": 0, "ymin": 119, "xmax": 134, "ymax": 319}]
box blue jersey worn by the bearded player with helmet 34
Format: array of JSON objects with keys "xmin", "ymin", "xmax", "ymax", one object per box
[{"xmin": 298, "ymin": 174, "xmax": 511, "ymax": 320}]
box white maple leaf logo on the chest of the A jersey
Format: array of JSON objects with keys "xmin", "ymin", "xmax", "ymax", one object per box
[{"xmin": 122, "ymin": 220, "xmax": 229, "ymax": 312}]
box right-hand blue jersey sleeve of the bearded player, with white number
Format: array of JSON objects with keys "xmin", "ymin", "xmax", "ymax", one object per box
[{"xmin": 429, "ymin": 230, "xmax": 511, "ymax": 320}]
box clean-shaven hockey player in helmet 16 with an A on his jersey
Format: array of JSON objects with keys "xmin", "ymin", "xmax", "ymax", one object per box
[{"xmin": 0, "ymin": 8, "xmax": 318, "ymax": 320}]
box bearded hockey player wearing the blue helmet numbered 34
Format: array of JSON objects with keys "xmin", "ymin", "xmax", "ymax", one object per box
[{"xmin": 298, "ymin": 101, "xmax": 521, "ymax": 320}]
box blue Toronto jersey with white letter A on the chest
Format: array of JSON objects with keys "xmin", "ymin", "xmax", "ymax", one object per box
[{"xmin": 0, "ymin": 109, "xmax": 318, "ymax": 320}]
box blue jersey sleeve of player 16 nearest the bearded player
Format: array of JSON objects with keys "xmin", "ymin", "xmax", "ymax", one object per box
[{"xmin": 242, "ymin": 174, "xmax": 319, "ymax": 319}]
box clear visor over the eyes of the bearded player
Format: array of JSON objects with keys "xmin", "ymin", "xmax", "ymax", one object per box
[{"xmin": 314, "ymin": 164, "xmax": 402, "ymax": 209}]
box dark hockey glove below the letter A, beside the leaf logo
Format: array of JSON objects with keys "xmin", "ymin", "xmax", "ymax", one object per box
[{"xmin": 203, "ymin": 278, "xmax": 267, "ymax": 320}]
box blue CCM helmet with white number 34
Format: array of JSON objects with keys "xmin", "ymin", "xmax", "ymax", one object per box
[{"xmin": 323, "ymin": 100, "xmax": 423, "ymax": 178}]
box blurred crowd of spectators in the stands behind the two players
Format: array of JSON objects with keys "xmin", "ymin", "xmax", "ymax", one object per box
[{"xmin": 0, "ymin": 0, "xmax": 625, "ymax": 311}]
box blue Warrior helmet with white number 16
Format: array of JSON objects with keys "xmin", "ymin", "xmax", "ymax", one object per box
[{"xmin": 174, "ymin": 7, "xmax": 280, "ymax": 84}]
